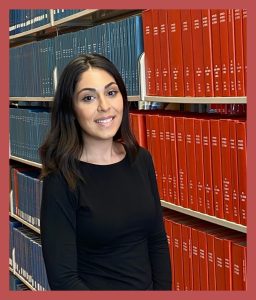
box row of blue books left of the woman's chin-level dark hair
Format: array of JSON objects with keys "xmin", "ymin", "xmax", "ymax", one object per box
[{"xmin": 10, "ymin": 107, "xmax": 51, "ymax": 163}]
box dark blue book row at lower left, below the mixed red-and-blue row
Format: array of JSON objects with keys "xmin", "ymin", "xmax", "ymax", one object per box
[{"xmin": 10, "ymin": 220, "xmax": 50, "ymax": 291}]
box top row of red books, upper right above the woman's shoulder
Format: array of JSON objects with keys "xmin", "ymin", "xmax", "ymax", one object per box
[{"xmin": 142, "ymin": 9, "xmax": 247, "ymax": 97}]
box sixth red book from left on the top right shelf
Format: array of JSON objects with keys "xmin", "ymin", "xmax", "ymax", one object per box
[{"xmin": 191, "ymin": 9, "xmax": 205, "ymax": 97}]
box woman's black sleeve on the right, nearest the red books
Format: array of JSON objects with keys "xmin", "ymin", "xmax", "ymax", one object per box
[{"xmin": 144, "ymin": 153, "xmax": 172, "ymax": 290}]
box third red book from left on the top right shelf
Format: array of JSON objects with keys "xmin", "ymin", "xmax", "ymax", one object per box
[{"xmin": 158, "ymin": 9, "xmax": 172, "ymax": 96}]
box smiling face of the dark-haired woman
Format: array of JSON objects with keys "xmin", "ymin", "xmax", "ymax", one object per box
[{"xmin": 74, "ymin": 68, "xmax": 123, "ymax": 140}]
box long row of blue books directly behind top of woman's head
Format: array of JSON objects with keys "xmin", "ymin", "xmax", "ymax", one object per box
[{"xmin": 10, "ymin": 16, "xmax": 144, "ymax": 97}]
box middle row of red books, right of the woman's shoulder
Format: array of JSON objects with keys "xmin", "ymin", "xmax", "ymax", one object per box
[{"xmin": 130, "ymin": 111, "xmax": 247, "ymax": 225}]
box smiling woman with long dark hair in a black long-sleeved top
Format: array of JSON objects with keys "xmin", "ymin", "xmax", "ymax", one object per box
[{"xmin": 40, "ymin": 54, "xmax": 171, "ymax": 290}]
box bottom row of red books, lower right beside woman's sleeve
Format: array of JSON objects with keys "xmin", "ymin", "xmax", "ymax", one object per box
[{"xmin": 164, "ymin": 211, "xmax": 247, "ymax": 291}]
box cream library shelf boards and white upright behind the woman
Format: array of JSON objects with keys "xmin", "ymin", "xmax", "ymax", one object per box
[{"xmin": 9, "ymin": 9, "xmax": 247, "ymax": 290}]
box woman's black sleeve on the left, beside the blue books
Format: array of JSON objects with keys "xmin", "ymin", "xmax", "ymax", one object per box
[{"xmin": 40, "ymin": 174, "xmax": 89, "ymax": 290}]
